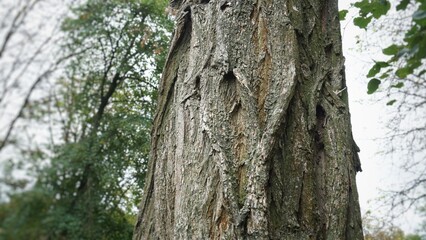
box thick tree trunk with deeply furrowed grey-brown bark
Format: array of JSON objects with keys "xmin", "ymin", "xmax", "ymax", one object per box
[{"xmin": 134, "ymin": 0, "xmax": 363, "ymax": 240}]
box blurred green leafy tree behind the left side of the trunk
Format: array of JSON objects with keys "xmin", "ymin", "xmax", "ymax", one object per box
[{"xmin": 0, "ymin": 0, "xmax": 171, "ymax": 239}]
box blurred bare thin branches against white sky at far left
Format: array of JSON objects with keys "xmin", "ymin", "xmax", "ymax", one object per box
[{"xmin": 0, "ymin": 0, "xmax": 70, "ymax": 197}]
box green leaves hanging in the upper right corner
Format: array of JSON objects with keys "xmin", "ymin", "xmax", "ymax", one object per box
[{"xmin": 354, "ymin": 0, "xmax": 426, "ymax": 101}]
